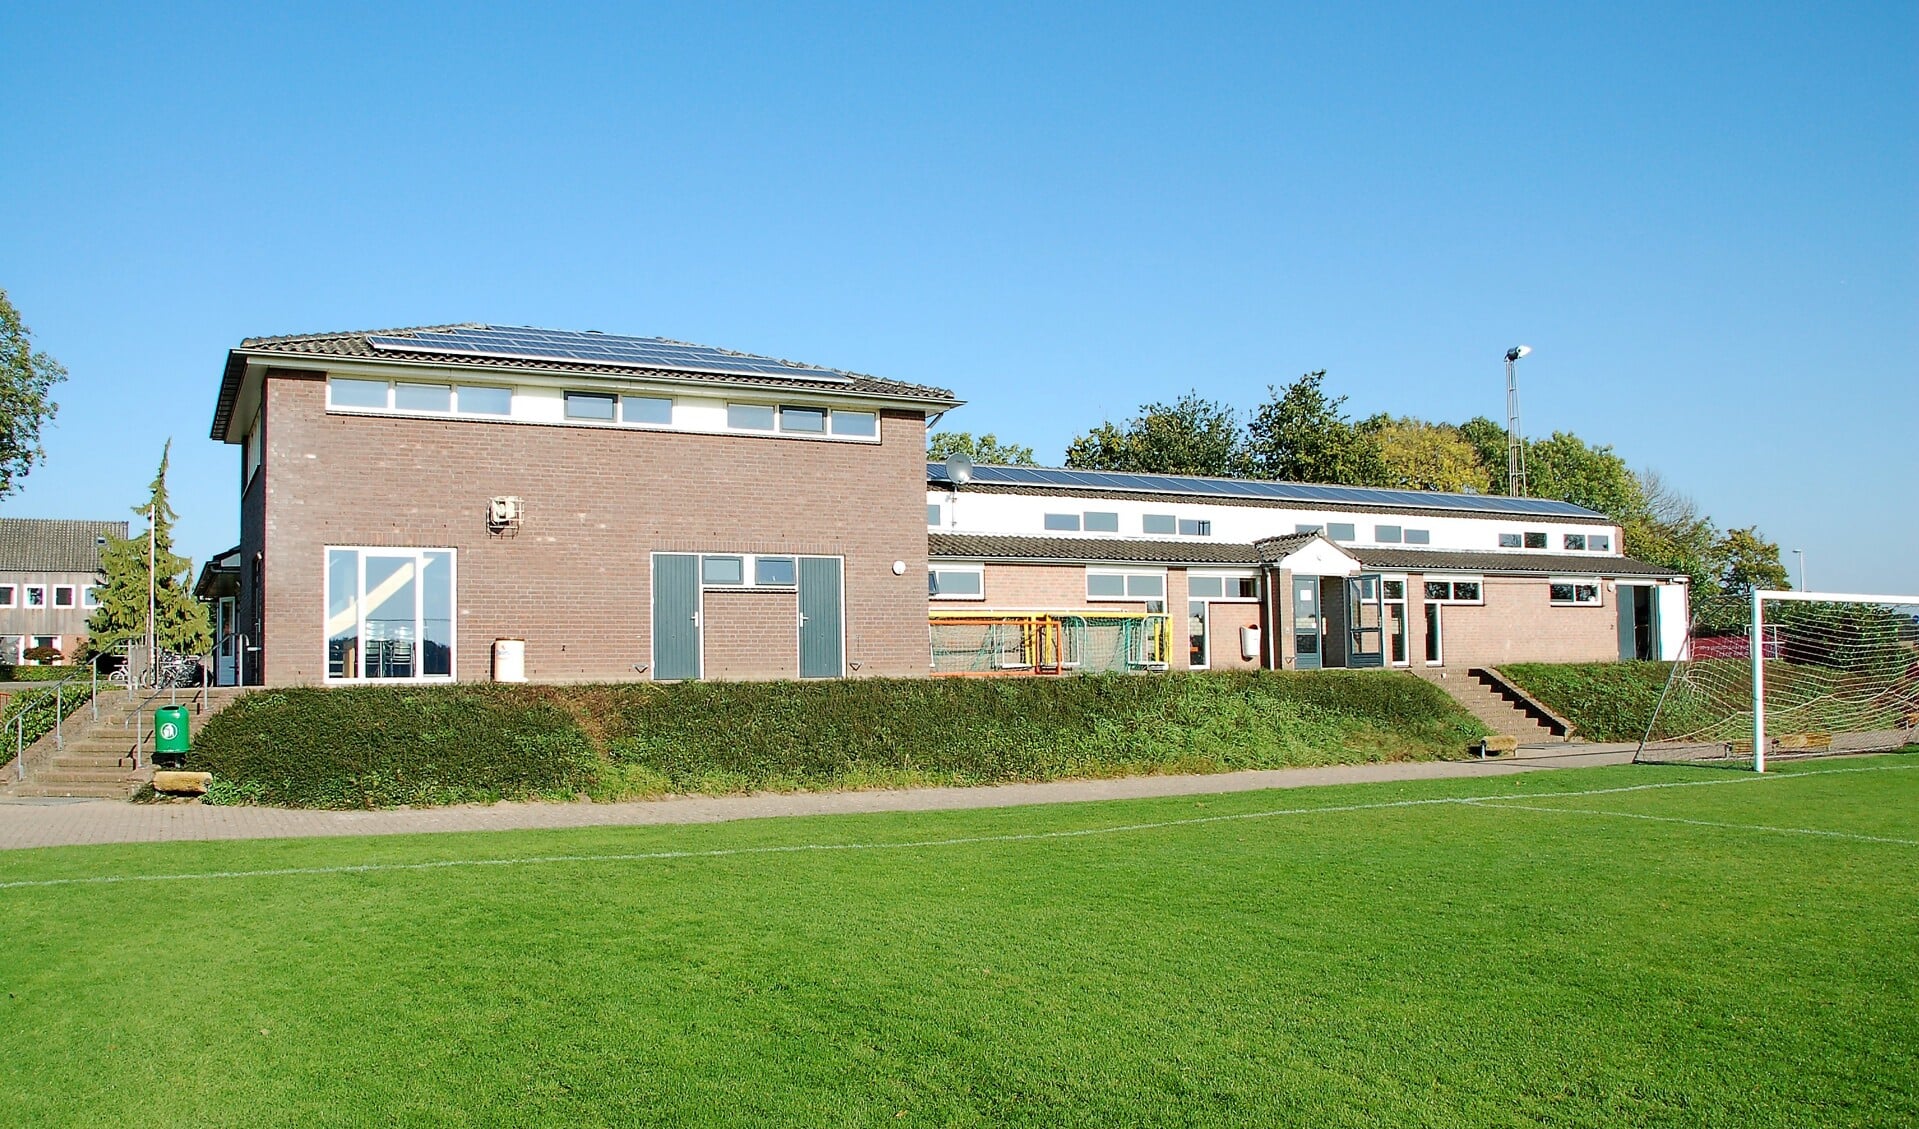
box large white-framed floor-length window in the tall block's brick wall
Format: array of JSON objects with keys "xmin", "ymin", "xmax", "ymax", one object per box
[{"xmin": 324, "ymin": 547, "xmax": 455, "ymax": 680}]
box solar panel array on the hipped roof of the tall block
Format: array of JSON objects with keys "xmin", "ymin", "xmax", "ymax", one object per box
[{"xmin": 367, "ymin": 324, "xmax": 852, "ymax": 384}]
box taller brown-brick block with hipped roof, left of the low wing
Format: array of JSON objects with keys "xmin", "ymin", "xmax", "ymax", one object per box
[{"xmin": 213, "ymin": 326, "xmax": 958, "ymax": 685}]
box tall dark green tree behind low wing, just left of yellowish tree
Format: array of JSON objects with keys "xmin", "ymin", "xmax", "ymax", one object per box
[{"xmin": 1245, "ymin": 369, "xmax": 1387, "ymax": 486}]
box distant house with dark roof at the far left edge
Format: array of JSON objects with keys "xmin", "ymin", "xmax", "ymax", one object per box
[{"xmin": 0, "ymin": 518, "xmax": 127, "ymax": 664}]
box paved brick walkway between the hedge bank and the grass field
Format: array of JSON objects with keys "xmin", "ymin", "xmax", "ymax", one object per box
[{"xmin": 0, "ymin": 745, "xmax": 1633, "ymax": 851}]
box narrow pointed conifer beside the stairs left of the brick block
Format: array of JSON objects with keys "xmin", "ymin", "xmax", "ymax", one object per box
[{"xmin": 86, "ymin": 440, "xmax": 213, "ymax": 655}]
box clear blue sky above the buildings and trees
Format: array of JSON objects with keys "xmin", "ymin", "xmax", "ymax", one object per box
[{"xmin": 0, "ymin": 2, "xmax": 1919, "ymax": 591}]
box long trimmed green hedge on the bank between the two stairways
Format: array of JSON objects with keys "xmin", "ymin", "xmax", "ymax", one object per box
[{"xmin": 188, "ymin": 672, "xmax": 1485, "ymax": 806}]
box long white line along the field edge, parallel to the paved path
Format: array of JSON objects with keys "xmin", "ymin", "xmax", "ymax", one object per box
[{"xmin": 0, "ymin": 762, "xmax": 1919, "ymax": 889}]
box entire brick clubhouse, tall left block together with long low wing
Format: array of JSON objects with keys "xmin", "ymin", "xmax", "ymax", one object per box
[{"xmin": 210, "ymin": 324, "xmax": 1687, "ymax": 685}]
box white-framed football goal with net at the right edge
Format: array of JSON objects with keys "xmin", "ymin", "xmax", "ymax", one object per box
[{"xmin": 1637, "ymin": 591, "xmax": 1919, "ymax": 772}]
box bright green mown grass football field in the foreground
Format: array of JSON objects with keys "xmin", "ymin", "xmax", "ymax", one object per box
[{"xmin": 0, "ymin": 755, "xmax": 1919, "ymax": 1127}]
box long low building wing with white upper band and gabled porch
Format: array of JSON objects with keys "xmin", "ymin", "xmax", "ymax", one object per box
[{"xmin": 927, "ymin": 463, "xmax": 1687, "ymax": 672}]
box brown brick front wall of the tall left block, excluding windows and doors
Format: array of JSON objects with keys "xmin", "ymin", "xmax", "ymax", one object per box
[{"xmin": 257, "ymin": 371, "xmax": 927, "ymax": 684}]
